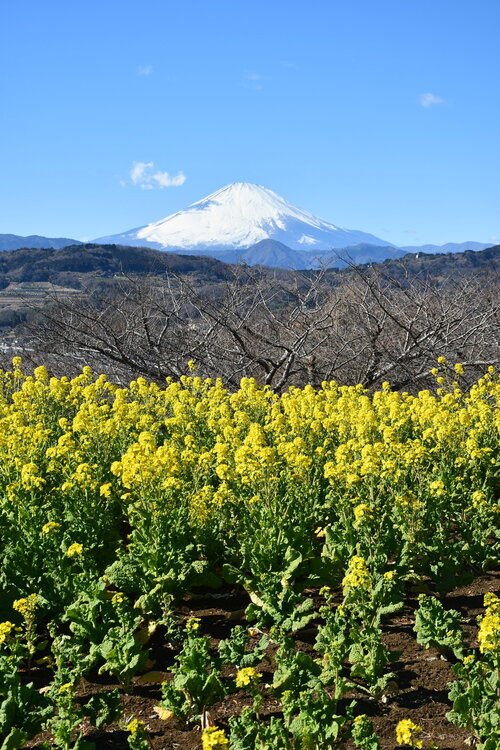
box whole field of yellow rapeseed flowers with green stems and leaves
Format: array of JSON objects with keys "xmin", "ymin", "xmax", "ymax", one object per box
[{"xmin": 0, "ymin": 358, "xmax": 500, "ymax": 750}]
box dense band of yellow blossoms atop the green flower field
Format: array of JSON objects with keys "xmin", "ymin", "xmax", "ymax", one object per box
[{"xmin": 0, "ymin": 358, "xmax": 500, "ymax": 616}]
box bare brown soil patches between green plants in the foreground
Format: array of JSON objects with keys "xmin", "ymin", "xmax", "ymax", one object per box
[{"xmin": 26, "ymin": 572, "xmax": 500, "ymax": 750}]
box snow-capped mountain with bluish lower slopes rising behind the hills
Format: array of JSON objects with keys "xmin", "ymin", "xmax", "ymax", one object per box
[{"xmin": 96, "ymin": 182, "xmax": 391, "ymax": 255}]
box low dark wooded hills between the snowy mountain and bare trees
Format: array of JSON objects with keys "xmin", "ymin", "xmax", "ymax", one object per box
[{"xmin": 0, "ymin": 243, "xmax": 500, "ymax": 334}]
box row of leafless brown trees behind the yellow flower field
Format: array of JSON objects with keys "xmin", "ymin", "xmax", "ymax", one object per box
[{"xmin": 21, "ymin": 264, "xmax": 500, "ymax": 390}]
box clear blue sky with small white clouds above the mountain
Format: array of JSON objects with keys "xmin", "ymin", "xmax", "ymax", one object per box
[{"xmin": 0, "ymin": 0, "xmax": 500, "ymax": 245}]
